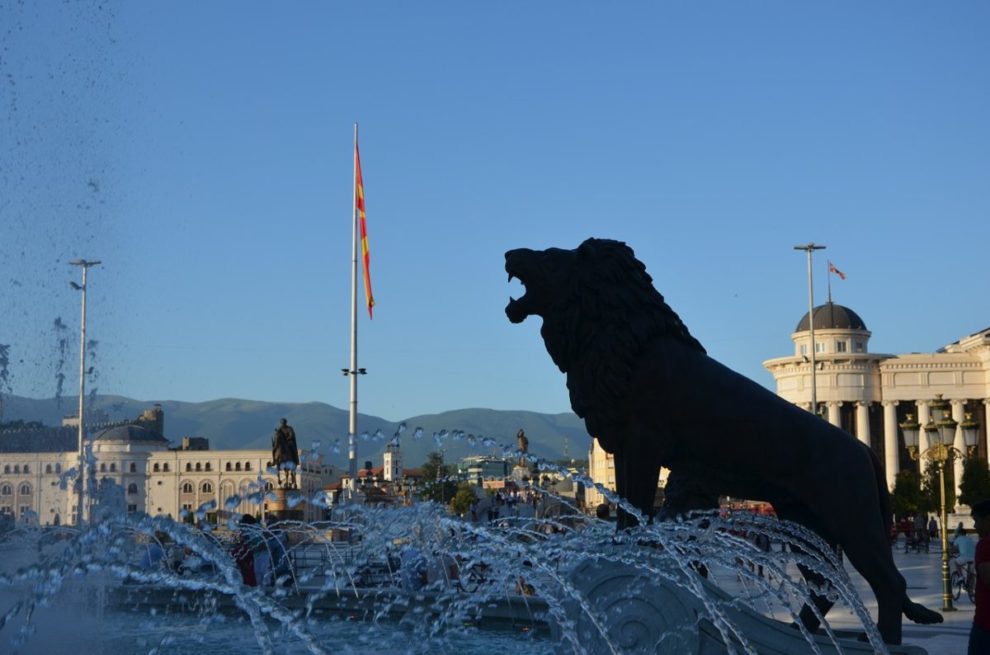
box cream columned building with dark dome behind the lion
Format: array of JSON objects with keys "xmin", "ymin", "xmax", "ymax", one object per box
[{"xmin": 763, "ymin": 302, "xmax": 990, "ymax": 497}]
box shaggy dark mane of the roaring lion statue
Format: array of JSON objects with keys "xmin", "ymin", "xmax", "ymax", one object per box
[{"xmin": 541, "ymin": 239, "xmax": 705, "ymax": 449}]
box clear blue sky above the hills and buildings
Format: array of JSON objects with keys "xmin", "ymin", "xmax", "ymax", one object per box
[{"xmin": 0, "ymin": 0, "xmax": 990, "ymax": 427}]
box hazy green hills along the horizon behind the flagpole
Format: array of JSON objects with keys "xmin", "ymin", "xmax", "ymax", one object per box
[{"xmin": 2, "ymin": 395, "xmax": 591, "ymax": 468}]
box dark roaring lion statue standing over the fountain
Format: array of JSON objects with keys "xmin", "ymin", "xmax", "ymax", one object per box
[{"xmin": 505, "ymin": 239, "xmax": 942, "ymax": 644}]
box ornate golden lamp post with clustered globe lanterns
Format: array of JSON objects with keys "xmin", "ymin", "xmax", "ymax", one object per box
[{"xmin": 901, "ymin": 394, "xmax": 979, "ymax": 612}]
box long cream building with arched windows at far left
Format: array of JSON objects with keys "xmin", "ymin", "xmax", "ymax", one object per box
[{"xmin": 0, "ymin": 406, "xmax": 331, "ymax": 525}]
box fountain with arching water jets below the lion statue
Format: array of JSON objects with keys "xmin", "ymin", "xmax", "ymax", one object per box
[{"xmin": 0, "ymin": 440, "xmax": 923, "ymax": 655}]
